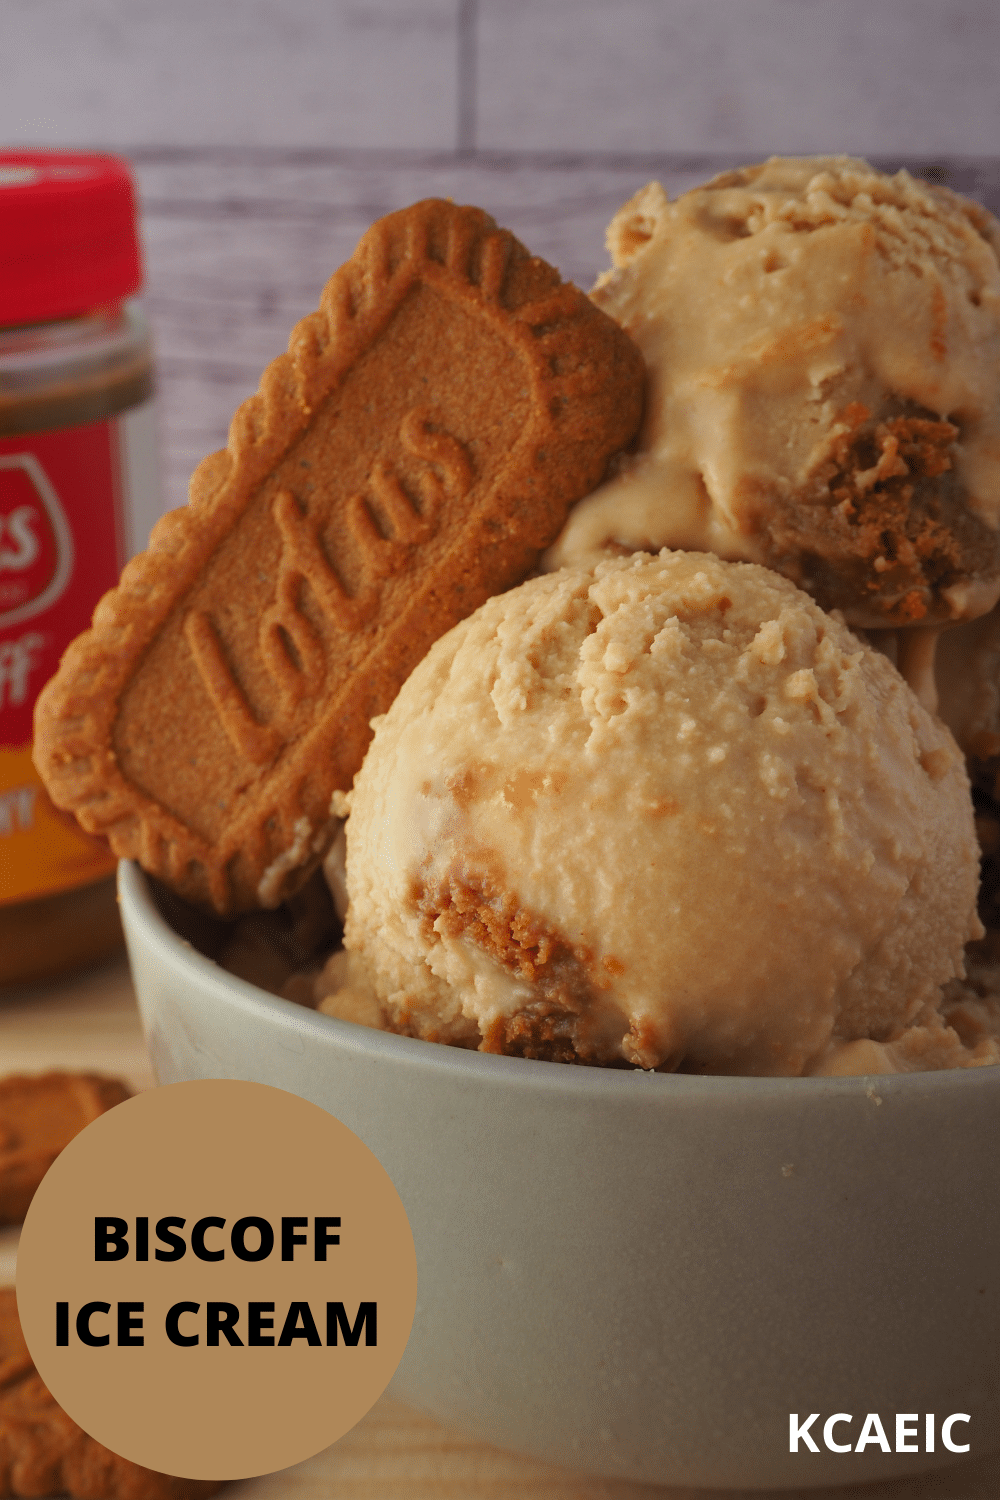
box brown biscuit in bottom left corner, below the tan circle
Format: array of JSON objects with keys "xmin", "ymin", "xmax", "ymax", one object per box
[{"xmin": 0, "ymin": 1287, "xmax": 222, "ymax": 1500}]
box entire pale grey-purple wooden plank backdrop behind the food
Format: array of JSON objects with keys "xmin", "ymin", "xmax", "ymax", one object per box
[{"xmin": 0, "ymin": 0, "xmax": 1000, "ymax": 506}]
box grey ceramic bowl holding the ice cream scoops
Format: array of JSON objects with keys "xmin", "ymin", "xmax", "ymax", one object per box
[{"xmin": 120, "ymin": 866, "xmax": 1000, "ymax": 1488}]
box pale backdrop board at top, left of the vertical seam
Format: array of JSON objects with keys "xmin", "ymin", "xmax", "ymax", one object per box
[{"xmin": 0, "ymin": 0, "xmax": 457, "ymax": 150}]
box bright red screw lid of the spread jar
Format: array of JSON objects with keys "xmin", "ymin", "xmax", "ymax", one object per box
[{"xmin": 0, "ymin": 152, "xmax": 142, "ymax": 326}]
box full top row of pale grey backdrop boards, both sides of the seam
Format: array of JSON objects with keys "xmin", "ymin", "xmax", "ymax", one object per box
[{"xmin": 0, "ymin": 0, "xmax": 1000, "ymax": 155}]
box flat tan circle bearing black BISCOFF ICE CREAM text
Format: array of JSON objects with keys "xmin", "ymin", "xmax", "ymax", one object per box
[{"xmin": 16, "ymin": 1080, "xmax": 417, "ymax": 1479}]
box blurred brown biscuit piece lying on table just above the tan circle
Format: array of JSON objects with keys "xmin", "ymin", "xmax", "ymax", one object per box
[{"xmin": 0, "ymin": 1073, "xmax": 129, "ymax": 1224}]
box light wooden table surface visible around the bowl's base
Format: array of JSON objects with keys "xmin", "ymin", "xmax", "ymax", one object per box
[{"xmin": 0, "ymin": 959, "xmax": 1000, "ymax": 1500}]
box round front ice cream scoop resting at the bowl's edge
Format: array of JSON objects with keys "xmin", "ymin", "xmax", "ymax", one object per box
[{"xmin": 334, "ymin": 551, "xmax": 981, "ymax": 1074}]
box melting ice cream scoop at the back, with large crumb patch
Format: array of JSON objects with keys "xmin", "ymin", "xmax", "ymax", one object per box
[{"xmin": 552, "ymin": 156, "xmax": 1000, "ymax": 627}]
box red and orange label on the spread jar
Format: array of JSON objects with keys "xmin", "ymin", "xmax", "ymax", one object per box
[{"xmin": 0, "ymin": 413, "xmax": 153, "ymax": 905}]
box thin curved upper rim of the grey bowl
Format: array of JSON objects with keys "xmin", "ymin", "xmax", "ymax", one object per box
[{"xmin": 118, "ymin": 860, "xmax": 1000, "ymax": 1104}]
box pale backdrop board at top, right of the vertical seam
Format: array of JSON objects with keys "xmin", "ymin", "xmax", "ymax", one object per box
[{"xmin": 478, "ymin": 0, "xmax": 1000, "ymax": 156}]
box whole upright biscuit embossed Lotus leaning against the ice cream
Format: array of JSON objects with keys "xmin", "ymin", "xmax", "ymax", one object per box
[{"xmin": 34, "ymin": 200, "xmax": 643, "ymax": 914}]
